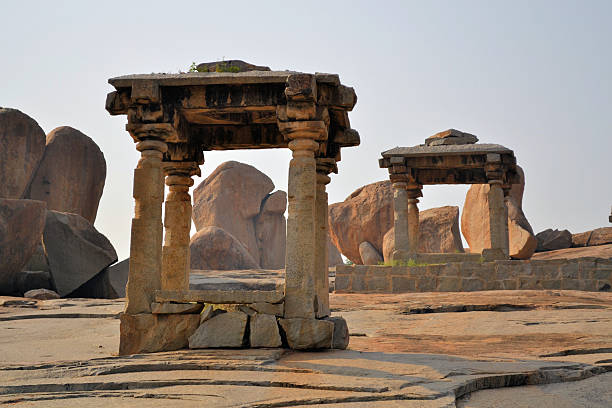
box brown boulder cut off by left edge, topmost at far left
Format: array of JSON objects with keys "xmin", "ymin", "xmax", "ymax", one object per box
[{"xmin": 0, "ymin": 108, "xmax": 45, "ymax": 199}]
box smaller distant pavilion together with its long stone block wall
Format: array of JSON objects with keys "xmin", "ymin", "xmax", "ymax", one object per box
[{"xmin": 335, "ymin": 129, "xmax": 612, "ymax": 293}]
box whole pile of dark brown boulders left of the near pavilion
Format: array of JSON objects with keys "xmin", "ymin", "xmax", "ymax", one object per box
[{"xmin": 0, "ymin": 108, "xmax": 122, "ymax": 297}]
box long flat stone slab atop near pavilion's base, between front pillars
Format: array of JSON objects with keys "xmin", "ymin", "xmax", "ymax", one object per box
[{"xmin": 155, "ymin": 290, "xmax": 285, "ymax": 304}]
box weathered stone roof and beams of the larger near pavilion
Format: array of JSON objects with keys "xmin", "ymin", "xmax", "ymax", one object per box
[{"xmin": 106, "ymin": 70, "xmax": 360, "ymax": 162}]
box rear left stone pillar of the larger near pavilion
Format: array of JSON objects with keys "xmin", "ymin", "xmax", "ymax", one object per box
[{"xmin": 161, "ymin": 162, "xmax": 199, "ymax": 290}]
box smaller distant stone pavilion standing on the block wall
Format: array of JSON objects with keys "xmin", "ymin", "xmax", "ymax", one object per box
[{"xmin": 379, "ymin": 129, "xmax": 519, "ymax": 263}]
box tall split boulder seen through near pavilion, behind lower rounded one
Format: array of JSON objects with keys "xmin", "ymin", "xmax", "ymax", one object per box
[{"xmin": 193, "ymin": 161, "xmax": 287, "ymax": 269}]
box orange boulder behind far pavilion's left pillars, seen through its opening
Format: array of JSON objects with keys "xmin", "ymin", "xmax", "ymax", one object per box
[{"xmin": 383, "ymin": 206, "xmax": 463, "ymax": 262}]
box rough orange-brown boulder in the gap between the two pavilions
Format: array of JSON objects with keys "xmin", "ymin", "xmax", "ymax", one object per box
[{"xmin": 329, "ymin": 181, "xmax": 393, "ymax": 264}]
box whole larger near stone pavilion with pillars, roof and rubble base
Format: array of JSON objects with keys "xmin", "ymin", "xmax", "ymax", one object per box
[{"xmin": 106, "ymin": 60, "xmax": 360, "ymax": 354}]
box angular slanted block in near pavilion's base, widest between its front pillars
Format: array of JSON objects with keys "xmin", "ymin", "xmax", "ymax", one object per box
[{"xmin": 189, "ymin": 311, "xmax": 249, "ymax": 349}]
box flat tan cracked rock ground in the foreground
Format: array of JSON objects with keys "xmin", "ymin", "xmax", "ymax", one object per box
[{"xmin": 0, "ymin": 291, "xmax": 612, "ymax": 408}]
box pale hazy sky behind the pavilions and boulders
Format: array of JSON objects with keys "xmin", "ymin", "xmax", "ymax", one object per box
[{"xmin": 0, "ymin": 0, "xmax": 612, "ymax": 258}]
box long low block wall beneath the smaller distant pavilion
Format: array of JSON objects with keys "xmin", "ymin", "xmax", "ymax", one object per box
[{"xmin": 335, "ymin": 258, "xmax": 612, "ymax": 293}]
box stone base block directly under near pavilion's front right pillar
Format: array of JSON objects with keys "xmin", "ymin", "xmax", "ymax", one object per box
[{"xmin": 279, "ymin": 318, "xmax": 334, "ymax": 350}]
